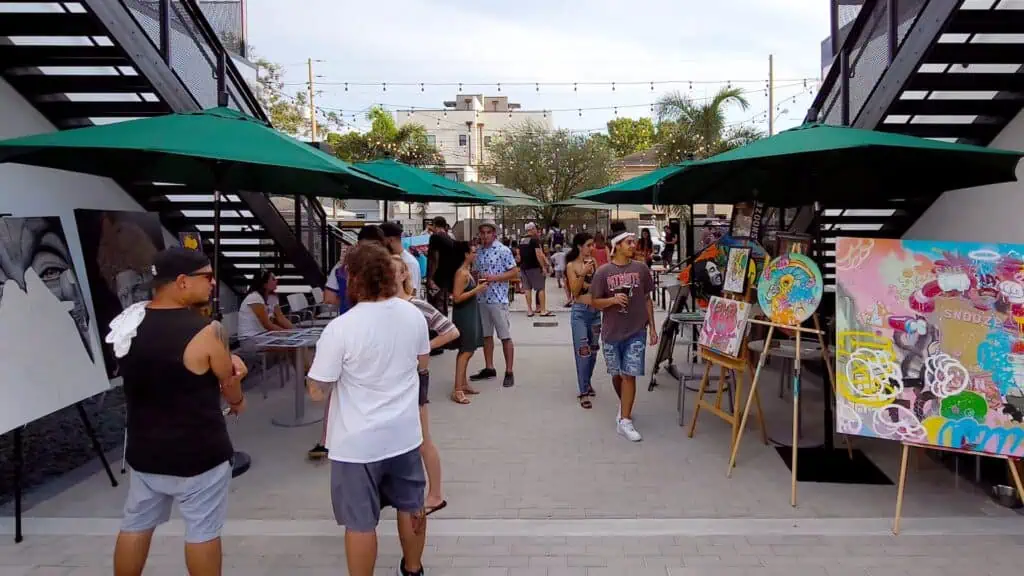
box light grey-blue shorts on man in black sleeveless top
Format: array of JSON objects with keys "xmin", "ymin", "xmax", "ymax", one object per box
[{"xmin": 121, "ymin": 461, "xmax": 231, "ymax": 544}]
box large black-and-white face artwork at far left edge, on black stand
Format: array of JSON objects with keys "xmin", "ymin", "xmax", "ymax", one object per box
[{"xmin": 0, "ymin": 217, "xmax": 110, "ymax": 434}]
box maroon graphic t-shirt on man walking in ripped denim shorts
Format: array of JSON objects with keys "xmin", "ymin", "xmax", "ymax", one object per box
[{"xmin": 590, "ymin": 260, "xmax": 654, "ymax": 343}]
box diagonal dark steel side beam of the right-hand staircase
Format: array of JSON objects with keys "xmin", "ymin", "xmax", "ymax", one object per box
[{"xmin": 851, "ymin": 0, "xmax": 962, "ymax": 130}]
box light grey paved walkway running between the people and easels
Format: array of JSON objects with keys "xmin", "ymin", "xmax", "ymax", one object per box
[{"xmin": 0, "ymin": 297, "xmax": 1024, "ymax": 576}]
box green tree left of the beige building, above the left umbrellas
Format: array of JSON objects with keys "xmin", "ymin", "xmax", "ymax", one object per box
[{"xmin": 327, "ymin": 107, "xmax": 444, "ymax": 170}]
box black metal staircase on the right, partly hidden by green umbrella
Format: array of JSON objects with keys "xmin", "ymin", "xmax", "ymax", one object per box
[{"xmin": 808, "ymin": 0, "xmax": 1024, "ymax": 284}]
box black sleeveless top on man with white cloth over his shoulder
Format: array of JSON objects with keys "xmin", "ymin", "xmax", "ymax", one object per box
[{"xmin": 120, "ymin": 308, "xmax": 233, "ymax": 478}]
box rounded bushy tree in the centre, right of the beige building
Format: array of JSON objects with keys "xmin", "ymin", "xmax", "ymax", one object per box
[{"xmin": 481, "ymin": 122, "xmax": 618, "ymax": 221}]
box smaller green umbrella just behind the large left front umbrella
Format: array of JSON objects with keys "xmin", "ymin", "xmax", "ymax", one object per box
[{"xmin": 352, "ymin": 158, "xmax": 497, "ymax": 204}]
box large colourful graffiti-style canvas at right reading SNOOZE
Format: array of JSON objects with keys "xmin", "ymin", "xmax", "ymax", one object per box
[{"xmin": 836, "ymin": 238, "xmax": 1024, "ymax": 457}]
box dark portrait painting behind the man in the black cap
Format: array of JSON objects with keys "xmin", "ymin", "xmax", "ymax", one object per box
[{"xmin": 75, "ymin": 209, "xmax": 164, "ymax": 378}]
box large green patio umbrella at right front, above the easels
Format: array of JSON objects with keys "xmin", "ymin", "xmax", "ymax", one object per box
[{"xmin": 657, "ymin": 124, "xmax": 1024, "ymax": 207}]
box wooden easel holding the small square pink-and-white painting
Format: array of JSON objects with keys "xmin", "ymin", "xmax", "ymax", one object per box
[{"xmin": 687, "ymin": 288, "xmax": 768, "ymax": 451}]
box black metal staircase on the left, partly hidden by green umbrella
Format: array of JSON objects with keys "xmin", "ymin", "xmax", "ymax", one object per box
[{"xmin": 0, "ymin": 0, "xmax": 337, "ymax": 292}]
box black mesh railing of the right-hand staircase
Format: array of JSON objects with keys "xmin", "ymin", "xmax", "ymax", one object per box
[{"xmin": 807, "ymin": 0, "xmax": 929, "ymax": 128}]
